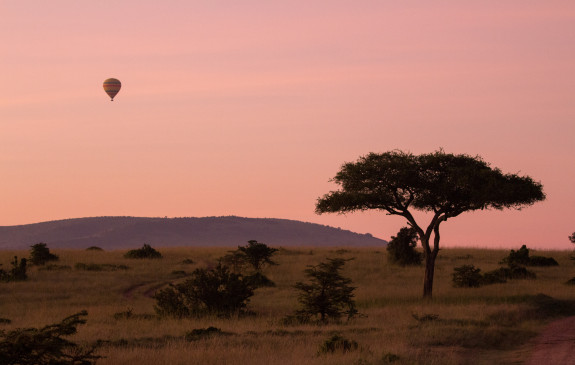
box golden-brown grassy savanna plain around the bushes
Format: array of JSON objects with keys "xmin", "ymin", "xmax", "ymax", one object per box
[{"xmin": 0, "ymin": 248, "xmax": 575, "ymax": 365}]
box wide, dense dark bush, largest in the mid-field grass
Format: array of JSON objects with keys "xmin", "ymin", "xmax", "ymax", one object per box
[{"xmin": 154, "ymin": 264, "xmax": 254, "ymax": 317}]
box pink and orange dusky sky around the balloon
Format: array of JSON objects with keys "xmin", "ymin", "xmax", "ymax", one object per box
[{"xmin": 0, "ymin": 0, "xmax": 575, "ymax": 249}]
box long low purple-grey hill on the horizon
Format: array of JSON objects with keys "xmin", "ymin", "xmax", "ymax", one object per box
[{"xmin": 0, "ymin": 216, "xmax": 387, "ymax": 250}]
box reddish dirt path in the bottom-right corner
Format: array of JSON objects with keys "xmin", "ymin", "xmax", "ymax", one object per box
[{"xmin": 525, "ymin": 317, "xmax": 575, "ymax": 365}]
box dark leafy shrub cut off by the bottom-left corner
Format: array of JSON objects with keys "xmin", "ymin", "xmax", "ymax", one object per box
[{"xmin": 0, "ymin": 311, "xmax": 101, "ymax": 365}]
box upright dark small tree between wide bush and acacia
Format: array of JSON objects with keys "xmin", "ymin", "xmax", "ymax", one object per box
[{"xmin": 295, "ymin": 258, "xmax": 358, "ymax": 323}]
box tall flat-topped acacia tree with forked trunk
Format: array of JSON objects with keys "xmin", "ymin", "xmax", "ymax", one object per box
[{"xmin": 316, "ymin": 150, "xmax": 545, "ymax": 298}]
